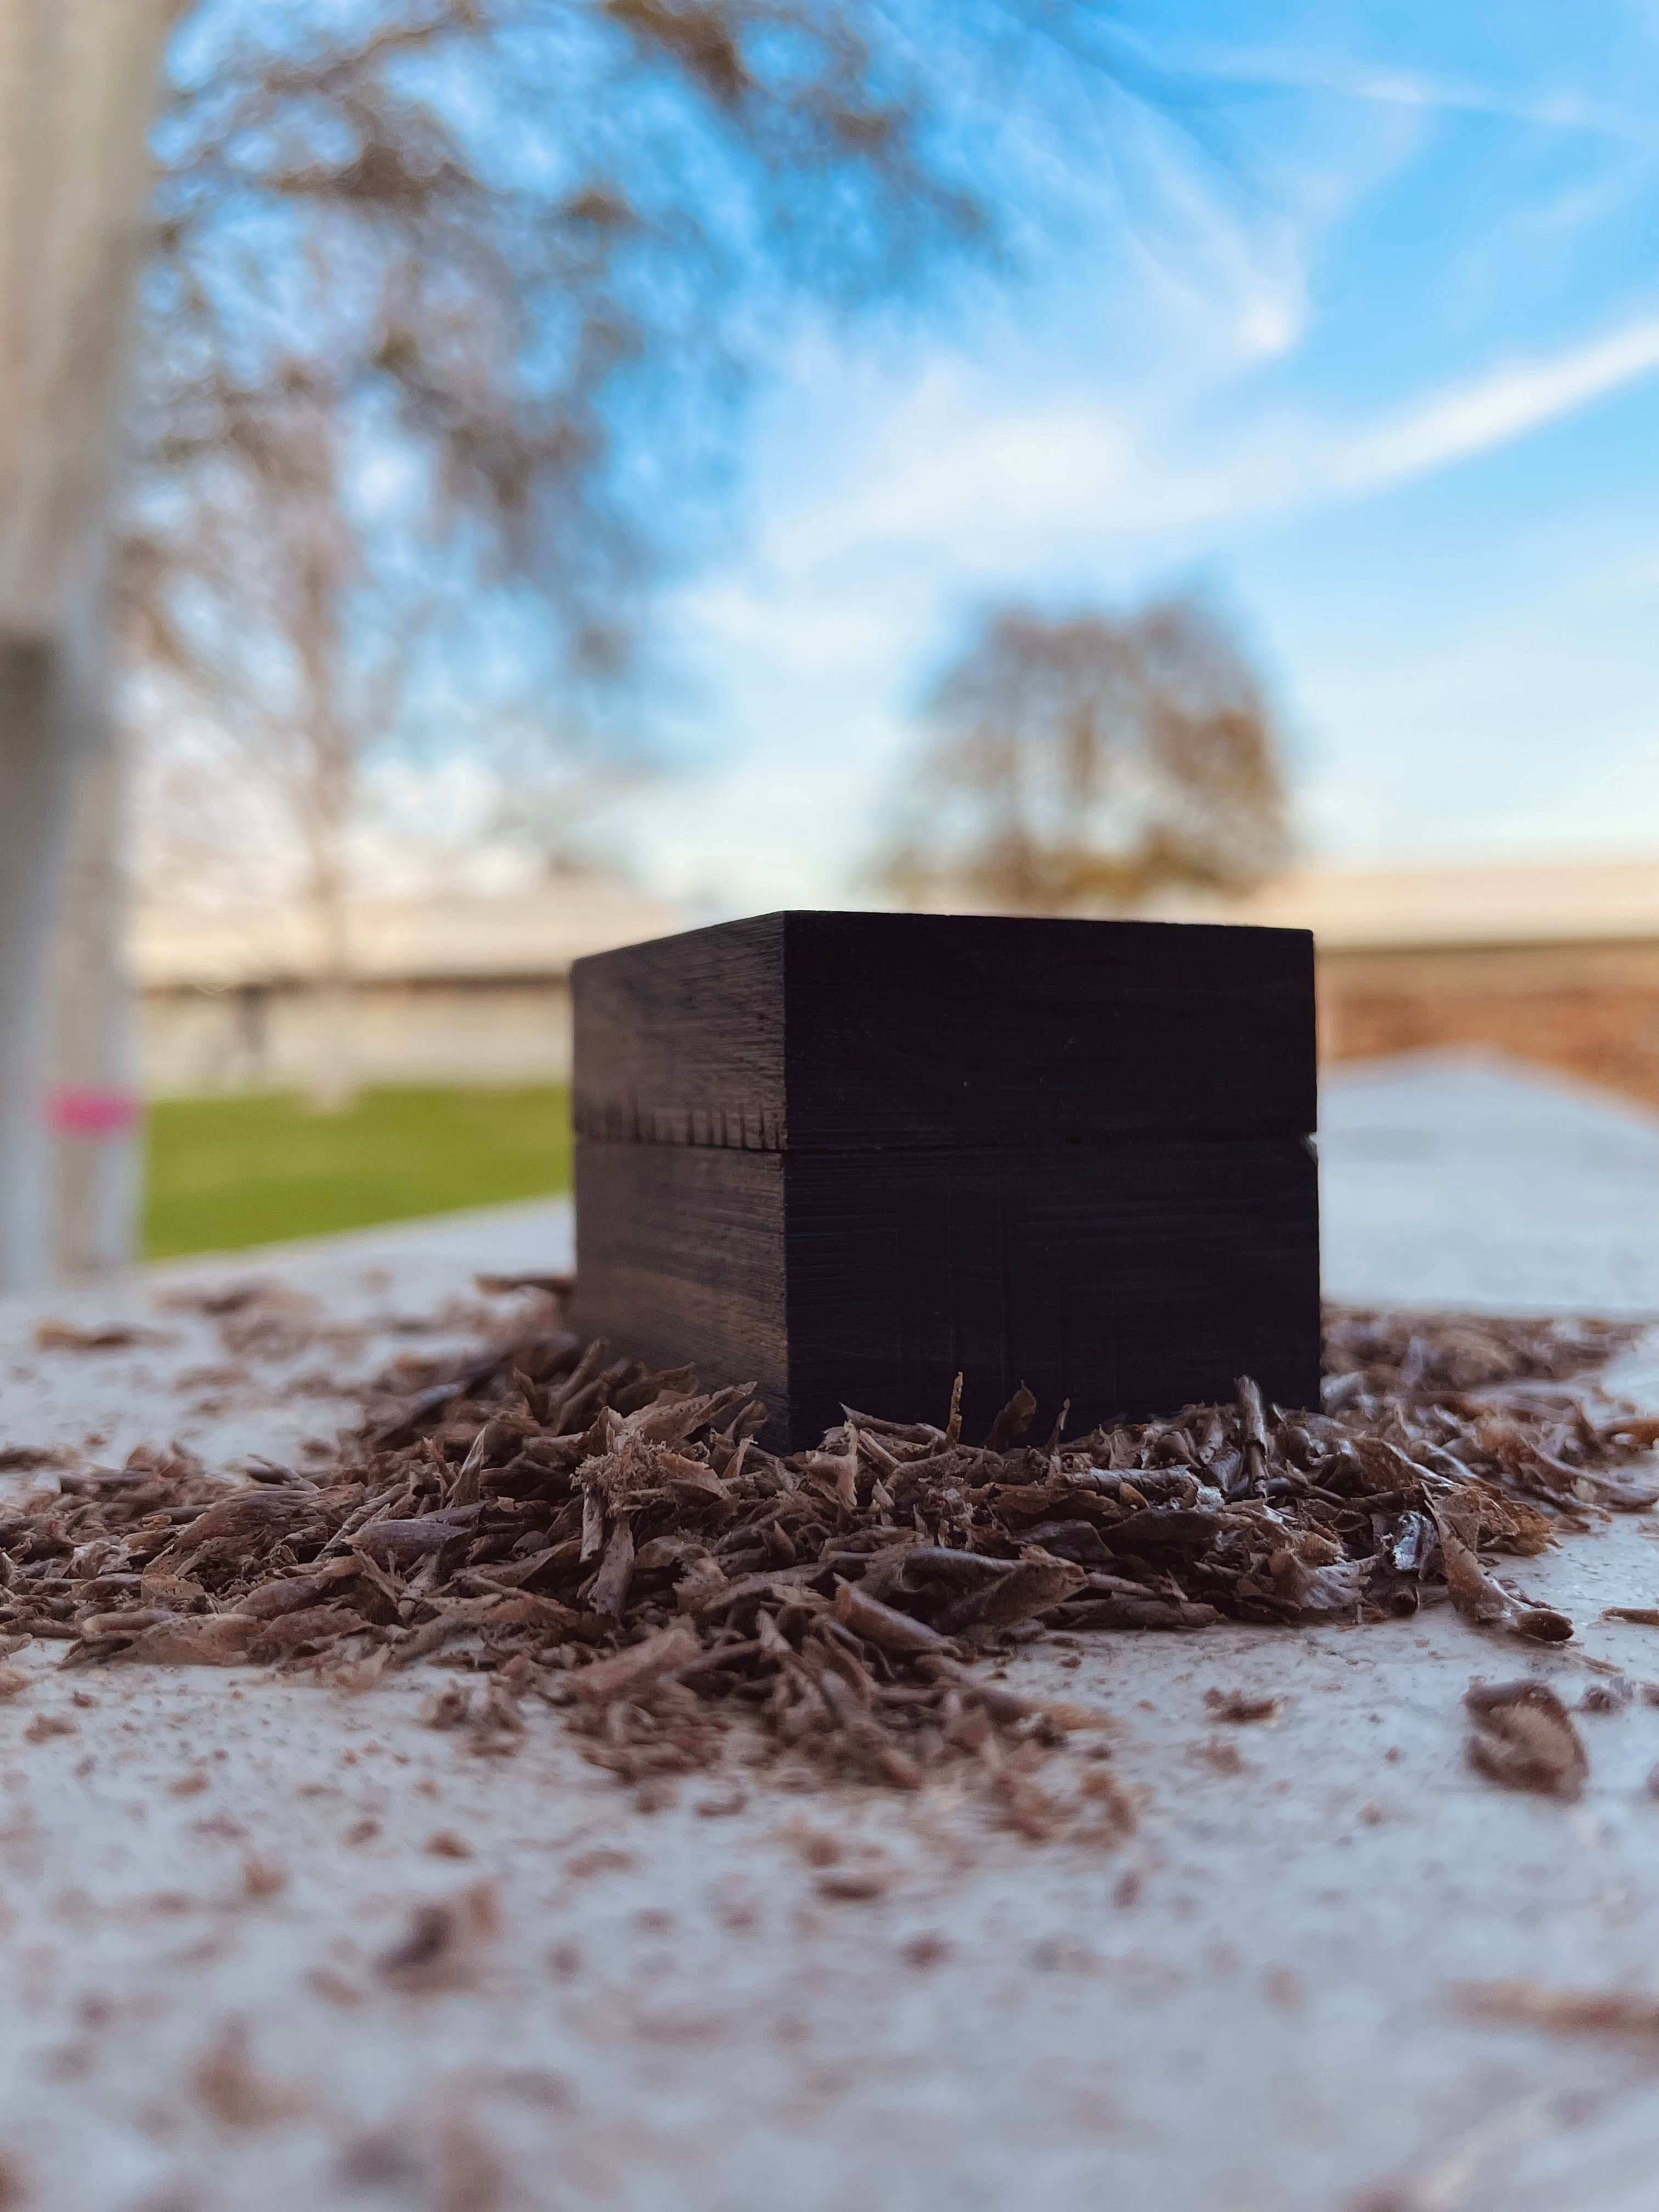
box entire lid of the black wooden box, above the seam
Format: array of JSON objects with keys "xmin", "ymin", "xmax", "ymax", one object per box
[{"xmin": 573, "ymin": 913, "xmax": 1316, "ymax": 1150}]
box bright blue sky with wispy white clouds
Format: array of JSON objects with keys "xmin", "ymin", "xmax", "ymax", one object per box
[{"xmin": 606, "ymin": 0, "xmax": 1659, "ymax": 909}]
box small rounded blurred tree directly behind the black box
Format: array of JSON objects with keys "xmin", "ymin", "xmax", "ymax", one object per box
[{"xmin": 881, "ymin": 597, "xmax": 1290, "ymax": 913}]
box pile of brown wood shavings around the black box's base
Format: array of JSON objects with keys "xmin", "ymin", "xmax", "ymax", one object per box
[{"xmin": 0, "ymin": 1296, "xmax": 1659, "ymax": 1834}]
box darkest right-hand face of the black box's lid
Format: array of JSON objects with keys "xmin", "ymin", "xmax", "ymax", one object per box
[{"xmin": 785, "ymin": 913, "xmax": 1318, "ymax": 1150}]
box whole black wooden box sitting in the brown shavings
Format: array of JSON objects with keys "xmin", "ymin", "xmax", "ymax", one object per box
[{"xmin": 573, "ymin": 913, "xmax": 1318, "ymax": 1449}]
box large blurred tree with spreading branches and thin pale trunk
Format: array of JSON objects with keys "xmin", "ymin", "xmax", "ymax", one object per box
[{"xmin": 124, "ymin": 0, "xmax": 1070, "ymax": 1104}]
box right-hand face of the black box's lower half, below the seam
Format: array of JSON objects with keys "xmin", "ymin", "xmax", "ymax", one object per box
[{"xmin": 785, "ymin": 1137, "xmax": 1318, "ymax": 1440}]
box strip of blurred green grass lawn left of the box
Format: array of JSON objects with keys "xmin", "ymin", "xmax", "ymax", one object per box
[{"xmin": 144, "ymin": 1084, "xmax": 571, "ymax": 1259}]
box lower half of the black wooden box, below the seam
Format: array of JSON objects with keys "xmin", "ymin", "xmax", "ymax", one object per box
[{"xmin": 575, "ymin": 1137, "xmax": 1318, "ymax": 1449}]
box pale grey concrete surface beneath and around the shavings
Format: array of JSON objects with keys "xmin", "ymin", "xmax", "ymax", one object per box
[{"xmin": 0, "ymin": 1066, "xmax": 1659, "ymax": 2212}]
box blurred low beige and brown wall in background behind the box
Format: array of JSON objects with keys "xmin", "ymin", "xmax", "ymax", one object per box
[{"xmin": 135, "ymin": 862, "xmax": 1659, "ymax": 1106}]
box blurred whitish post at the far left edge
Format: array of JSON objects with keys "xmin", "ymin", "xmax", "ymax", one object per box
[{"xmin": 0, "ymin": 0, "xmax": 175, "ymax": 1290}]
